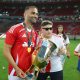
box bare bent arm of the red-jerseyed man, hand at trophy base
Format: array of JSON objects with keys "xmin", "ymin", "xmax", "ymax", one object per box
[{"xmin": 3, "ymin": 43, "xmax": 26, "ymax": 78}]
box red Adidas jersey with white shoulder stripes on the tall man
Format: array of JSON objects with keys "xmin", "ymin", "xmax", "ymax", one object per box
[{"xmin": 5, "ymin": 23, "xmax": 37, "ymax": 75}]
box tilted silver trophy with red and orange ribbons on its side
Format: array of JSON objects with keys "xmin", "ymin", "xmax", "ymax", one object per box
[{"xmin": 25, "ymin": 39, "xmax": 57, "ymax": 80}]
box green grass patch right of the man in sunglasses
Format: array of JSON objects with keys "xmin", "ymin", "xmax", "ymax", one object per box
[{"xmin": 64, "ymin": 40, "xmax": 80, "ymax": 80}]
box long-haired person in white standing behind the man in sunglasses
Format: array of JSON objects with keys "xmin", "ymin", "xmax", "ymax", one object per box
[{"xmin": 57, "ymin": 25, "xmax": 70, "ymax": 65}]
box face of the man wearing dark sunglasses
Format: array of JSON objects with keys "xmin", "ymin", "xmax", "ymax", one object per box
[{"xmin": 42, "ymin": 24, "xmax": 52, "ymax": 37}]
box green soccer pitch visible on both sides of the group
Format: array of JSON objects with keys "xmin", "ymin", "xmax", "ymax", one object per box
[{"xmin": 0, "ymin": 39, "xmax": 80, "ymax": 80}]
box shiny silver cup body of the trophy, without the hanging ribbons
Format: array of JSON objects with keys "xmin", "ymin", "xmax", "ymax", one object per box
[{"xmin": 33, "ymin": 39, "xmax": 56, "ymax": 69}]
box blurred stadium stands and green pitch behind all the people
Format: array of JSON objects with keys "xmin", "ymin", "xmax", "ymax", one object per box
[{"xmin": 0, "ymin": 0, "xmax": 80, "ymax": 80}]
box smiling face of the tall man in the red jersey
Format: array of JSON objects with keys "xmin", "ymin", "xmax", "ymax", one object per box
[{"xmin": 24, "ymin": 8, "xmax": 38, "ymax": 23}]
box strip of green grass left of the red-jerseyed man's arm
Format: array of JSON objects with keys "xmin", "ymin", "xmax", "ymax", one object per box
[{"xmin": 0, "ymin": 39, "xmax": 8, "ymax": 80}]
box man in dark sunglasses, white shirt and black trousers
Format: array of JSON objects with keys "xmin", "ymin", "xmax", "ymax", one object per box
[{"xmin": 37, "ymin": 20, "xmax": 66, "ymax": 80}]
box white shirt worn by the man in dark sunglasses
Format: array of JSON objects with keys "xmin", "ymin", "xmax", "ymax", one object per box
[{"xmin": 50, "ymin": 34, "xmax": 66, "ymax": 72}]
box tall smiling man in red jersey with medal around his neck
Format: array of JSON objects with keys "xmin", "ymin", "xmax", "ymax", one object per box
[{"xmin": 4, "ymin": 6, "xmax": 38, "ymax": 80}]
